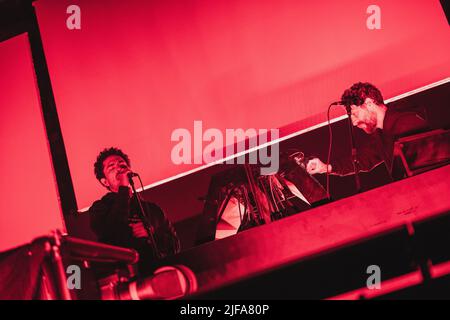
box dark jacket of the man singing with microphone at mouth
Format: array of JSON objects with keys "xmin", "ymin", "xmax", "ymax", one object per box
[{"xmin": 89, "ymin": 186, "xmax": 180, "ymax": 268}]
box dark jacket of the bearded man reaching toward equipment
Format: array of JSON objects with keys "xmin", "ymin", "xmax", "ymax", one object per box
[{"xmin": 331, "ymin": 108, "xmax": 430, "ymax": 175}]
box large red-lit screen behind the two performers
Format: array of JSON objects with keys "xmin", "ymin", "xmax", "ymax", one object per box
[{"xmin": 0, "ymin": 0, "xmax": 450, "ymax": 250}]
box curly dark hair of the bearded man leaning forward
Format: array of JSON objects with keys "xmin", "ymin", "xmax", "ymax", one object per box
[{"xmin": 341, "ymin": 82, "xmax": 384, "ymax": 107}]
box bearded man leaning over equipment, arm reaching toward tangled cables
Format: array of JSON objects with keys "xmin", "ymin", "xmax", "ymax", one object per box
[{"xmin": 306, "ymin": 82, "xmax": 429, "ymax": 175}]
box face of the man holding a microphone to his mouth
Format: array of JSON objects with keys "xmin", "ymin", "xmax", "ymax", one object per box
[{"xmin": 100, "ymin": 155, "xmax": 130, "ymax": 192}]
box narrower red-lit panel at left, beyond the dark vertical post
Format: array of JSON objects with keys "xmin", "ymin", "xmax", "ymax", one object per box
[{"xmin": 0, "ymin": 35, "xmax": 63, "ymax": 251}]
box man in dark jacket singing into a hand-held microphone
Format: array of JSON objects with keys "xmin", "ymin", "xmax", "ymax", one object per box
[{"xmin": 89, "ymin": 148, "xmax": 180, "ymax": 272}]
